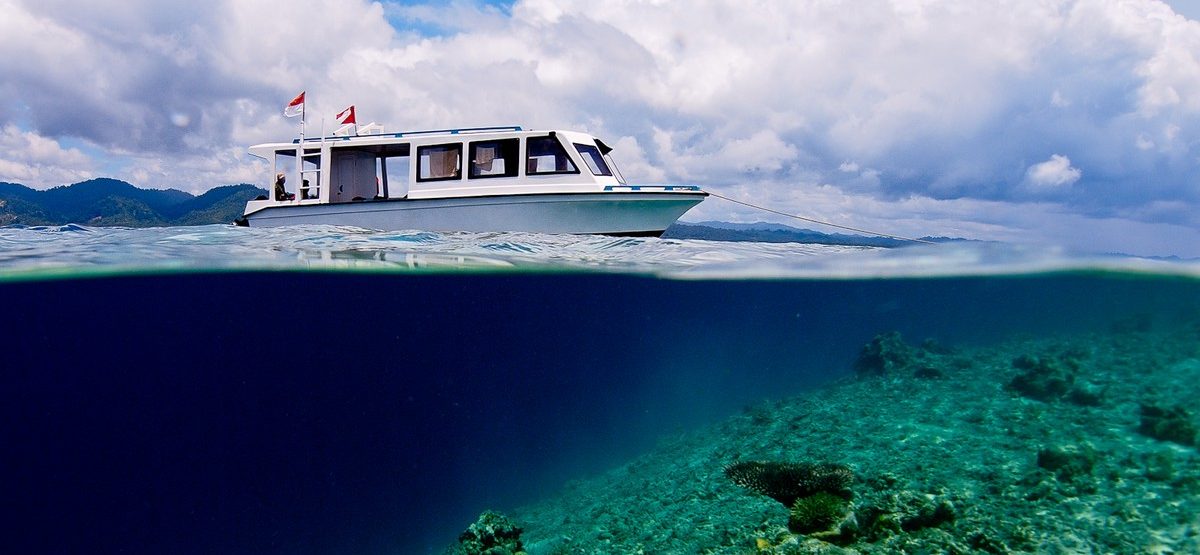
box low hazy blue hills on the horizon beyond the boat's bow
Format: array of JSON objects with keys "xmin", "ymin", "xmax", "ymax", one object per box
[{"xmin": 662, "ymin": 221, "xmax": 967, "ymax": 247}]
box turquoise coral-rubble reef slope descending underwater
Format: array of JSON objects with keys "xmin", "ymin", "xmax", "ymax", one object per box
[{"xmin": 512, "ymin": 322, "xmax": 1200, "ymax": 555}]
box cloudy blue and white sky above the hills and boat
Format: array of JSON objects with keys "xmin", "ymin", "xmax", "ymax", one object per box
[{"xmin": 0, "ymin": 0, "xmax": 1200, "ymax": 257}]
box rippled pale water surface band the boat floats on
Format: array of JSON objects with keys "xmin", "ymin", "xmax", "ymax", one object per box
[{"xmin": 0, "ymin": 225, "xmax": 1200, "ymax": 280}]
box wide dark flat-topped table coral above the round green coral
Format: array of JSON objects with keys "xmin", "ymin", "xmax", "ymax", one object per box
[{"xmin": 725, "ymin": 461, "xmax": 854, "ymax": 507}]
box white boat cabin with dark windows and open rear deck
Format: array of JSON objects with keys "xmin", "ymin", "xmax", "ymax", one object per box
[{"xmin": 250, "ymin": 126, "xmax": 625, "ymax": 205}]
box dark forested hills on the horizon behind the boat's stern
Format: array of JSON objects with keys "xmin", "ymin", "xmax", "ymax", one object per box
[{"xmin": 0, "ymin": 178, "xmax": 266, "ymax": 227}]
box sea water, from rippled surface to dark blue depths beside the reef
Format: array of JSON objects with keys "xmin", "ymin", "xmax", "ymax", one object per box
[{"xmin": 0, "ymin": 226, "xmax": 1200, "ymax": 555}]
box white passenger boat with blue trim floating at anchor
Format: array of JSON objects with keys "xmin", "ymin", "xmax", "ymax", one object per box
[{"xmin": 236, "ymin": 124, "xmax": 708, "ymax": 237}]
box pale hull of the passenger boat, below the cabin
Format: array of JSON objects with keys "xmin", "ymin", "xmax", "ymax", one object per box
[{"xmin": 240, "ymin": 191, "xmax": 707, "ymax": 237}]
